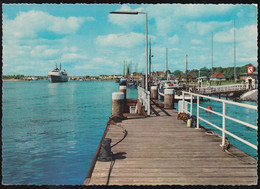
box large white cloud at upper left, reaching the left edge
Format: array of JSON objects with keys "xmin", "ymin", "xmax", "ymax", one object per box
[{"xmin": 3, "ymin": 10, "xmax": 86, "ymax": 39}]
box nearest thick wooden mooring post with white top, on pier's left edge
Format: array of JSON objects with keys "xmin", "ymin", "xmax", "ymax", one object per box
[{"xmin": 112, "ymin": 92, "xmax": 124, "ymax": 117}]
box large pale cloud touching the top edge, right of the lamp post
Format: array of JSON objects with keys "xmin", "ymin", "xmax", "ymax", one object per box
[{"xmin": 147, "ymin": 4, "xmax": 235, "ymax": 36}]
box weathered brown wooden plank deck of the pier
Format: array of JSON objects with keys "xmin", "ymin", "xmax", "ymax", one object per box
[{"xmin": 85, "ymin": 101, "xmax": 257, "ymax": 185}]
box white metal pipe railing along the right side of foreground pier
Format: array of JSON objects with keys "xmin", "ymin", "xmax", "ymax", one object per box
[{"xmin": 182, "ymin": 91, "xmax": 258, "ymax": 150}]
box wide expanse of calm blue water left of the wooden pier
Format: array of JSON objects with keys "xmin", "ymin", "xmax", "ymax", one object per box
[{"xmin": 2, "ymin": 81, "xmax": 137, "ymax": 185}]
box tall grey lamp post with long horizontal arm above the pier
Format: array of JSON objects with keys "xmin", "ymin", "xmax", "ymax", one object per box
[{"xmin": 110, "ymin": 11, "xmax": 148, "ymax": 91}]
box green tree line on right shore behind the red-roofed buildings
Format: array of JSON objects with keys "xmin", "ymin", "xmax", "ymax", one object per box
[{"xmin": 172, "ymin": 64, "xmax": 258, "ymax": 79}]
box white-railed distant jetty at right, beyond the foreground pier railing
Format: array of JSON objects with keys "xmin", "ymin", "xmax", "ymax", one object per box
[{"xmin": 196, "ymin": 84, "xmax": 248, "ymax": 94}]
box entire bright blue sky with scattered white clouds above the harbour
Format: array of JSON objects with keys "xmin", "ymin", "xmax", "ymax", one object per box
[{"xmin": 2, "ymin": 4, "xmax": 258, "ymax": 76}]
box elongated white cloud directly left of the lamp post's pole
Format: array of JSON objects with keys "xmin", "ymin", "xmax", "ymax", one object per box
[{"xmin": 96, "ymin": 32, "xmax": 145, "ymax": 48}]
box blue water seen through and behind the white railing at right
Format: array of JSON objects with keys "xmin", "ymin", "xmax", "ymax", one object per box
[{"xmin": 175, "ymin": 96, "xmax": 258, "ymax": 159}]
